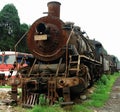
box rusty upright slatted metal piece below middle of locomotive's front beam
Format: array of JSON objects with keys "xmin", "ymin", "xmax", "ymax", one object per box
[{"xmin": 48, "ymin": 80, "xmax": 58, "ymax": 105}]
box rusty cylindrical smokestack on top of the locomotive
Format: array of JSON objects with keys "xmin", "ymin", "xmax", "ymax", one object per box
[{"xmin": 47, "ymin": 1, "xmax": 61, "ymax": 18}]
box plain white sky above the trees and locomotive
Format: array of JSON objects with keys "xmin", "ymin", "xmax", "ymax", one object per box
[{"xmin": 0, "ymin": 0, "xmax": 120, "ymax": 60}]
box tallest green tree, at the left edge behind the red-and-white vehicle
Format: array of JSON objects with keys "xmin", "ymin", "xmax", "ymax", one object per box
[{"xmin": 0, "ymin": 4, "xmax": 20, "ymax": 50}]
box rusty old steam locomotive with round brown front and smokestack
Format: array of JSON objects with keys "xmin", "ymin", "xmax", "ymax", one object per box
[{"xmin": 21, "ymin": 1, "xmax": 103, "ymax": 104}]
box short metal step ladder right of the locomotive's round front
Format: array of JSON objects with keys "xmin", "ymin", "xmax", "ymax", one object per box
[{"xmin": 68, "ymin": 55, "xmax": 80, "ymax": 76}]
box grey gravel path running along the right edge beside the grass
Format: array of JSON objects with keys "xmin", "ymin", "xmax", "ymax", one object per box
[{"xmin": 94, "ymin": 77, "xmax": 120, "ymax": 112}]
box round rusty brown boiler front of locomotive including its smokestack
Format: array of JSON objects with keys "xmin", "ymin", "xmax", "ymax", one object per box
[{"xmin": 27, "ymin": 2, "xmax": 68, "ymax": 61}]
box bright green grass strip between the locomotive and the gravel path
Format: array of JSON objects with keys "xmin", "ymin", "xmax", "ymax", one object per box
[{"xmin": 83, "ymin": 73, "xmax": 120, "ymax": 107}]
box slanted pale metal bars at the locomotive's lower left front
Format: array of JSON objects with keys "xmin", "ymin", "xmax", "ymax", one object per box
[{"xmin": 22, "ymin": 93, "xmax": 39, "ymax": 108}]
